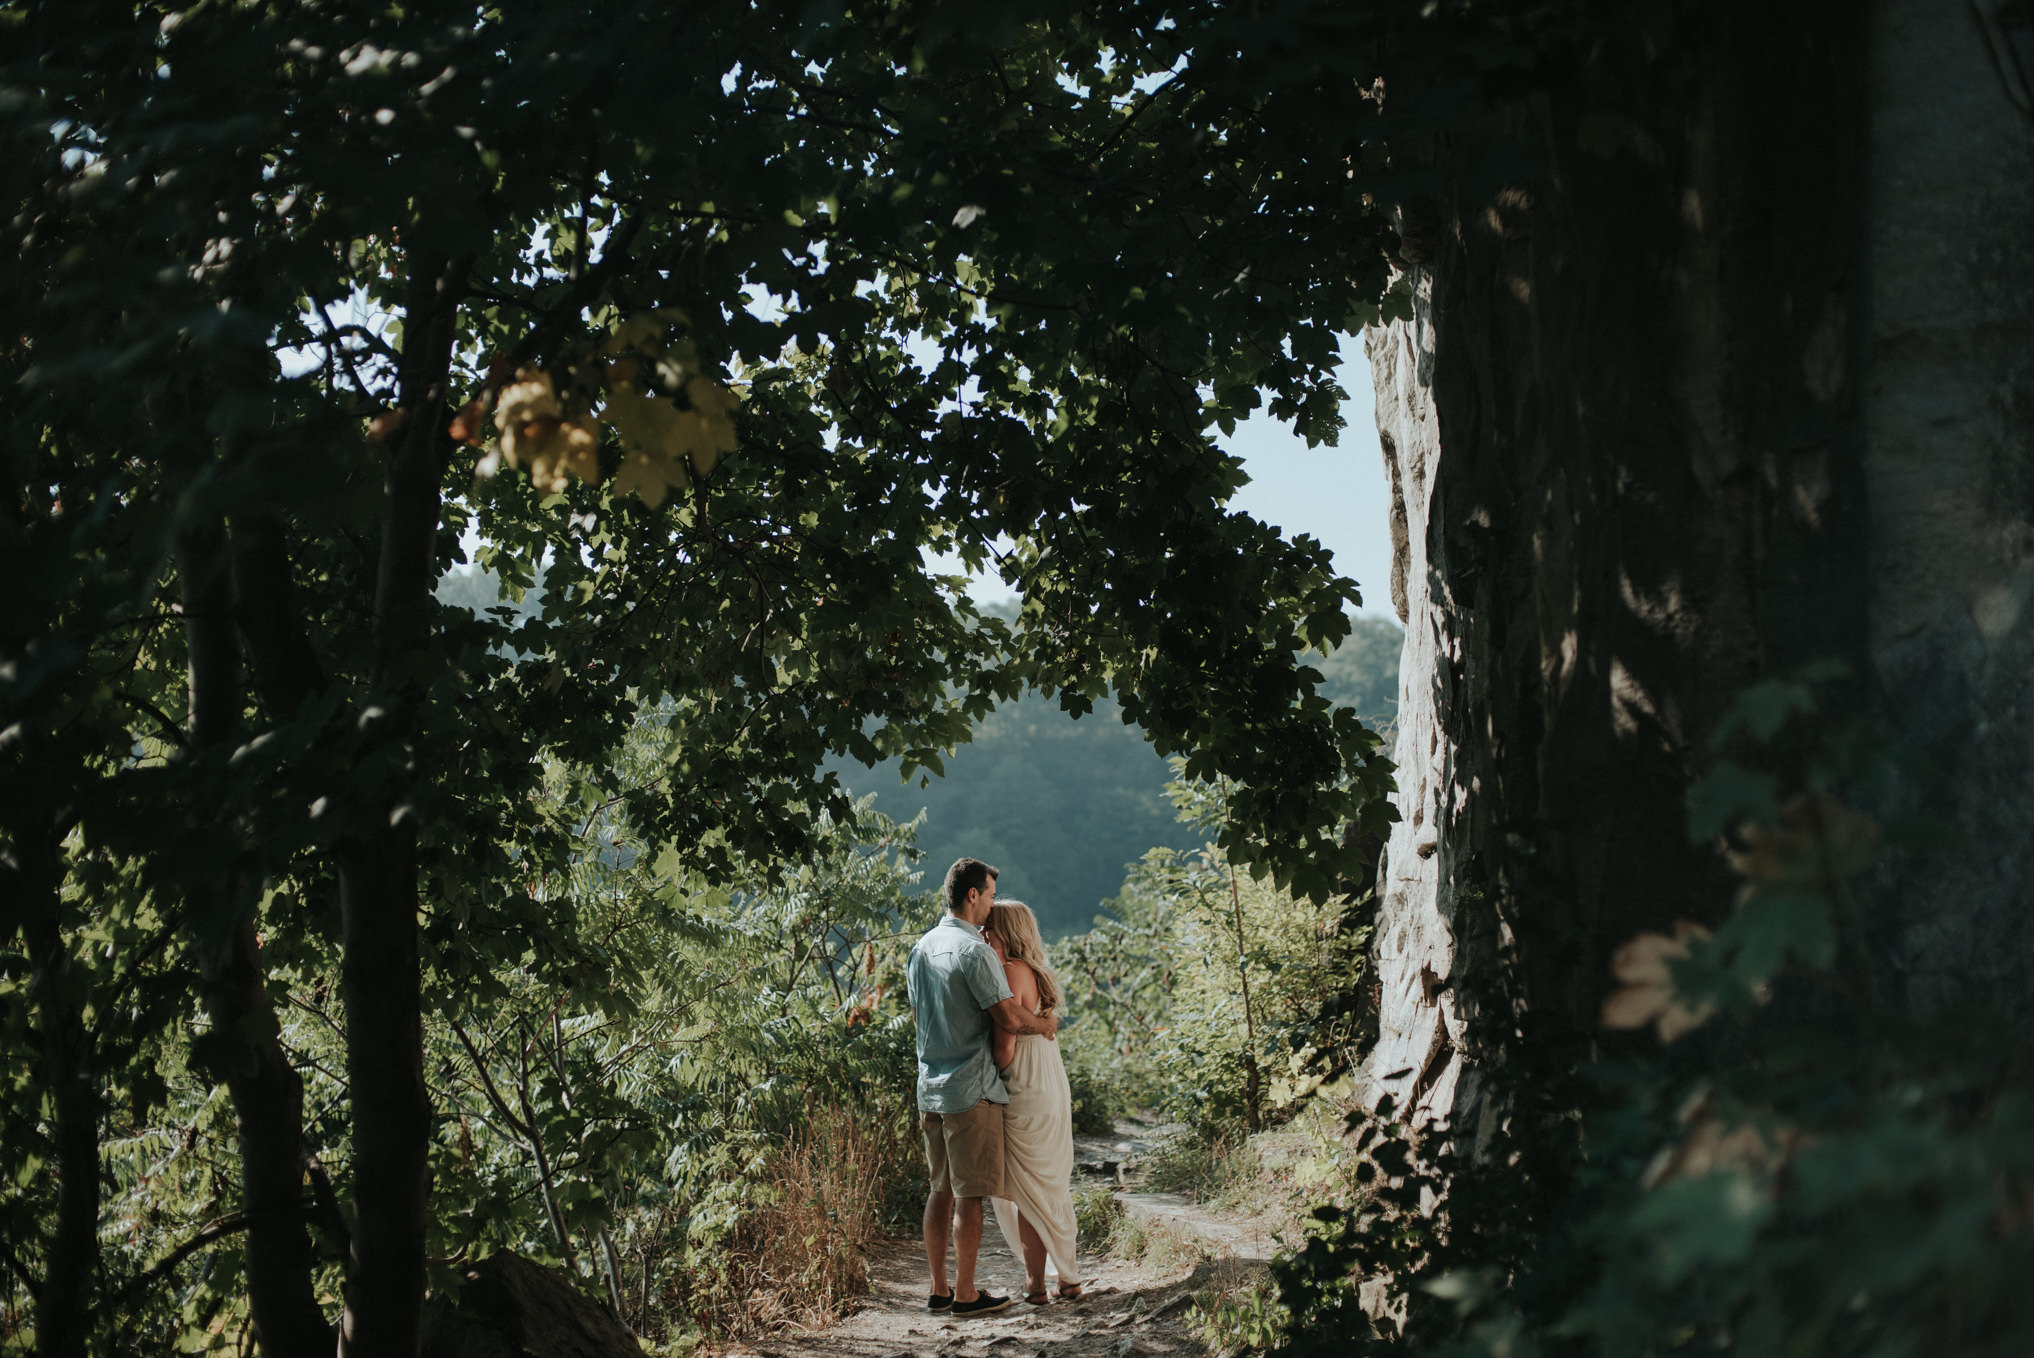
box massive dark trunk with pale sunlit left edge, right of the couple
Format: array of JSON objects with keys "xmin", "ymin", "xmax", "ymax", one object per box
[{"xmin": 1367, "ymin": 2, "xmax": 1867, "ymax": 1122}]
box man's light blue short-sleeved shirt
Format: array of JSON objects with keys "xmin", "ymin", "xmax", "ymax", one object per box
[{"xmin": 905, "ymin": 915, "xmax": 1011, "ymax": 1112}]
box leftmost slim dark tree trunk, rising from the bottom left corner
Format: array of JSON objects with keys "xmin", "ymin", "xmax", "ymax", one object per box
[{"xmin": 22, "ymin": 823, "xmax": 100, "ymax": 1358}]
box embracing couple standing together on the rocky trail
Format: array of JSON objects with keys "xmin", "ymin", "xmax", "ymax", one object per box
[{"xmin": 907, "ymin": 858, "xmax": 1080, "ymax": 1315}]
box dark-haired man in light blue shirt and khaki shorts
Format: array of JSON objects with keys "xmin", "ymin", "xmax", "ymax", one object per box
[{"xmin": 905, "ymin": 858, "xmax": 1060, "ymax": 1315}]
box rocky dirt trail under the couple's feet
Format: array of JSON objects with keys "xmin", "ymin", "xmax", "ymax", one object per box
[{"xmin": 730, "ymin": 1124, "xmax": 1277, "ymax": 1358}]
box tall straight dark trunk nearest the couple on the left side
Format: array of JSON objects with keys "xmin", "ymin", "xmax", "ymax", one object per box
[{"xmin": 338, "ymin": 250, "xmax": 466, "ymax": 1358}]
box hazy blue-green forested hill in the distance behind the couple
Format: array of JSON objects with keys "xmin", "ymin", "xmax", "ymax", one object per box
[{"xmin": 437, "ymin": 571, "xmax": 1403, "ymax": 935}]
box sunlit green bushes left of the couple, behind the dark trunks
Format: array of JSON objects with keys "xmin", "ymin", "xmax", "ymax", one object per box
[{"xmin": 1, "ymin": 712, "xmax": 932, "ymax": 1348}]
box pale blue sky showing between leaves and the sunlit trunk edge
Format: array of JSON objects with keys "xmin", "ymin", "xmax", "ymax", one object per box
[{"xmin": 942, "ymin": 337, "xmax": 1393, "ymax": 618}]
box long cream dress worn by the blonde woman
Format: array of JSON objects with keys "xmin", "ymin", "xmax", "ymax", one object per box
[{"xmin": 995, "ymin": 1033, "xmax": 1080, "ymax": 1287}]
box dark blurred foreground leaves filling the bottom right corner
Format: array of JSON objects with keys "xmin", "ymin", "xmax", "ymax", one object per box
[{"xmin": 1273, "ymin": 669, "xmax": 2034, "ymax": 1356}]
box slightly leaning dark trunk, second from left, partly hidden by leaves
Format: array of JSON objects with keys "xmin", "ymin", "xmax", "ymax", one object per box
[{"xmin": 177, "ymin": 524, "xmax": 334, "ymax": 1358}]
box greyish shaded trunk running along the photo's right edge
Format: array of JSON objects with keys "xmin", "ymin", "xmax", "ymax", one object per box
[{"xmin": 1865, "ymin": 0, "xmax": 2034, "ymax": 1035}]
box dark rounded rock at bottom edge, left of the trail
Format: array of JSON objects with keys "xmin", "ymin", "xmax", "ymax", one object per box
[{"xmin": 423, "ymin": 1254, "xmax": 643, "ymax": 1358}]
